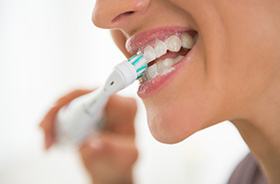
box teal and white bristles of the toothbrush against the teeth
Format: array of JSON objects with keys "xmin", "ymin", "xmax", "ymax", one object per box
[{"xmin": 127, "ymin": 53, "xmax": 148, "ymax": 79}]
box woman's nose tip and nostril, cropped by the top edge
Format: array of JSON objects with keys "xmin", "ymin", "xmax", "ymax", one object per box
[{"xmin": 92, "ymin": 0, "xmax": 151, "ymax": 29}]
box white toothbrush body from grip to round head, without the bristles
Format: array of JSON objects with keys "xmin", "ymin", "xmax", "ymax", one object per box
[{"xmin": 56, "ymin": 61, "xmax": 141, "ymax": 145}]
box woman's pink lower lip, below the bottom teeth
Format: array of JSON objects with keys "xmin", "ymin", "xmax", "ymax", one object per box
[{"xmin": 138, "ymin": 45, "xmax": 195, "ymax": 98}]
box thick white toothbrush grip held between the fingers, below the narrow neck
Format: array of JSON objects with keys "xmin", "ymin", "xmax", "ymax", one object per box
[{"xmin": 56, "ymin": 89, "xmax": 109, "ymax": 145}]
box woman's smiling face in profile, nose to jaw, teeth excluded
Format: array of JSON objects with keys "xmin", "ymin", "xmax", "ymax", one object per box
[{"xmin": 93, "ymin": 0, "xmax": 280, "ymax": 143}]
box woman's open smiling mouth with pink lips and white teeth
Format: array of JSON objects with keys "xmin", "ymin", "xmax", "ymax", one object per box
[{"xmin": 126, "ymin": 27, "xmax": 198, "ymax": 98}]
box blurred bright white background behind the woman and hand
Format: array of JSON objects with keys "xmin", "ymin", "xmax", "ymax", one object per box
[{"xmin": 0, "ymin": 0, "xmax": 248, "ymax": 184}]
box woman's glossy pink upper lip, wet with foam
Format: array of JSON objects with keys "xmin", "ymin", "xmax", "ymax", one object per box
[{"xmin": 125, "ymin": 26, "xmax": 190, "ymax": 54}]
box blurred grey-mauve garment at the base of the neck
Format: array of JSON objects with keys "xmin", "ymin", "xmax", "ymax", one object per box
[{"xmin": 228, "ymin": 154, "xmax": 267, "ymax": 184}]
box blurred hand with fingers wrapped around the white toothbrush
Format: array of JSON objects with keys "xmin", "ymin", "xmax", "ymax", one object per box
[{"xmin": 40, "ymin": 90, "xmax": 138, "ymax": 184}]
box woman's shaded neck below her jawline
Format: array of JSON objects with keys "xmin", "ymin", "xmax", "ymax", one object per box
[{"xmin": 232, "ymin": 88, "xmax": 280, "ymax": 184}]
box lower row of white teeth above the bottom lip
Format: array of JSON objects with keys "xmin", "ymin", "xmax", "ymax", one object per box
[{"xmin": 140, "ymin": 55, "xmax": 183, "ymax": 82}]
